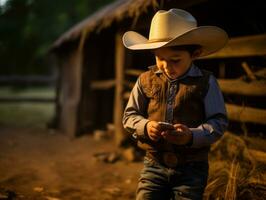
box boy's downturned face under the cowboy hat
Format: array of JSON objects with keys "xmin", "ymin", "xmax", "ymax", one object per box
[{"xmin": 154, "ymin": 47, "xmax": 194, "ymax": 79}]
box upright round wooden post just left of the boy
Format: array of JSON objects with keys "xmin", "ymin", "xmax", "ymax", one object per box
[{"xmin": 113, "ymin": 33, "xmax": 125, "ymax": 146}]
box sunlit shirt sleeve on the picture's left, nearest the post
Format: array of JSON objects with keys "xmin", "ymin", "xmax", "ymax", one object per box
[{"xmin": 123, "ymin": 79, "xmax": 149, "ymax": 138}]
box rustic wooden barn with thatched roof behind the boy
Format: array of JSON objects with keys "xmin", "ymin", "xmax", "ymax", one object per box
[{"xmin": 50, "ymin": 0, "xmax": 266, "ymax": 144}]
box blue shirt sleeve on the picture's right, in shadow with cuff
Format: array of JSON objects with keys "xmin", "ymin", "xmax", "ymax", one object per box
[{"xmin": 190, "ymin": 75, "xmax": 228, "ymax": 148}]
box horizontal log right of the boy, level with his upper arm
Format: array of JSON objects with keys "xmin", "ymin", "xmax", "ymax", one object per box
[{"xmin": 218, "ymin": 79, "xmax": 266, "ymax": 96}]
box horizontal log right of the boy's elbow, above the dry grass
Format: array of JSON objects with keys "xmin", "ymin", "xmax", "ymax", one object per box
[{"xmin": 226, "ymin": 104, "xmax": 266, "ymax": 125}]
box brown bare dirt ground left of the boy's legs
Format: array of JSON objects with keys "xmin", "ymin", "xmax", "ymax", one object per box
[{"xmin": 0, "ymin": 128, "xmax": 142, "ymax": 200}]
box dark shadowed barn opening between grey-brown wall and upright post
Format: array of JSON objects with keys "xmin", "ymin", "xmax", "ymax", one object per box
[{"xmin": 78, "ymin": 29, "xmax": 114, "ymax": 134}]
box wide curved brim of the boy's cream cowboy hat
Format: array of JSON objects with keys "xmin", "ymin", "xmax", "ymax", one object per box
[{"xmin": 123, "ymin": 26, "xmax": 228, "ymax": 57}]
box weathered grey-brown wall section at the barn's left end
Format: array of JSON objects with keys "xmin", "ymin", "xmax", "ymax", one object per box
[{"xmin": 55, "ymin": 41, "xmax": 82, "ymax": 137}]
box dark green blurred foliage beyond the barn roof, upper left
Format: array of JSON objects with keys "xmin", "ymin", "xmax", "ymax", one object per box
[{"xmin": 0, "ymin": 0, "xmax": 112, "ymax": 75}]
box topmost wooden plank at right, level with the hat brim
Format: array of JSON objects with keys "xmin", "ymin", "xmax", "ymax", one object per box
[{"xmin": 200, "ymin": 34, "xmax": 266, "ymax": 59}]
